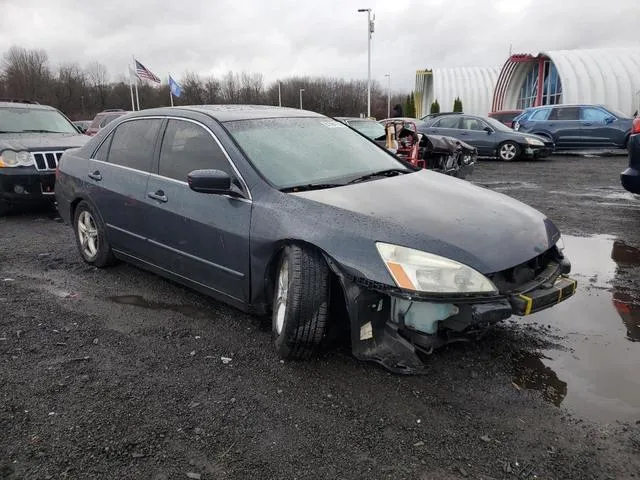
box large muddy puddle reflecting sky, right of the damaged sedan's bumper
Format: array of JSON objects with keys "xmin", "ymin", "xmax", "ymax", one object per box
[{"xmin": 513, "ymin": 236, "xmax": 640, "ymax": 423}]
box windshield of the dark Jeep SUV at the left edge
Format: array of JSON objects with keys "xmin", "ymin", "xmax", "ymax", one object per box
[{"xmin": 0, "ymin": 107, "xmax": 78, "ymax": 134}]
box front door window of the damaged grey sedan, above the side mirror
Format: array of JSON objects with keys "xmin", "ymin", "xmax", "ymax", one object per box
[{"xmin": 158, "ymin": 120, "xmax": 234, "ymax": 182}]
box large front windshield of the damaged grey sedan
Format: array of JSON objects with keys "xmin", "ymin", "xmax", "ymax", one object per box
[{"xmin": 225, "ymin": 118, "xmax": 406, "ymax": 189}]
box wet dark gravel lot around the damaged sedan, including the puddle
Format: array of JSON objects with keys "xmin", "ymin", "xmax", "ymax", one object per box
[{"xmin": 0, "ymin": 156, "xmax": 640, "ymax": 480}]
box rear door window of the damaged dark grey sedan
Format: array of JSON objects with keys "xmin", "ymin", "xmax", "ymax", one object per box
[{"xmin": 108, "ymin": 119, "xmax": 162, "ymax": 172}]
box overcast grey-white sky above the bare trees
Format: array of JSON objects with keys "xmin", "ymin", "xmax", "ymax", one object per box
[{"xmin": 0, "ymin": 0, "xmax": 640, "ymax": 90}]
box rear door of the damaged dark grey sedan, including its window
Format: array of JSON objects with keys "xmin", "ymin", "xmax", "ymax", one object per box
[{"xmin": 88, "ymin": 119, "xmax": 162, "ymax": 259}]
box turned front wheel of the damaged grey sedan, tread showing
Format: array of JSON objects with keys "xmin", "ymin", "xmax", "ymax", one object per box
[{"xmin": 272, "ymin": 245, "xmax": 330, "ymax": 360}]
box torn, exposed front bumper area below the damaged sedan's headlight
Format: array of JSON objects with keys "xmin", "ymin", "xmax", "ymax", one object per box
[{"xmin": 343, "ymin": 261, "xmax": 577, "ymax": 374}]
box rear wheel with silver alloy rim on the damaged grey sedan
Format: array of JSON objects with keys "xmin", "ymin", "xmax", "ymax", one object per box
[{"xmin": 73, "ymin": 201, "xmax": 115, "ymax": 268}]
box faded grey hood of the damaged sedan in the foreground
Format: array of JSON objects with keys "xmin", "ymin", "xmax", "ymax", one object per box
[{"xmin": 292, "ymin": 170, "xmax": 560, "ymax": 274}]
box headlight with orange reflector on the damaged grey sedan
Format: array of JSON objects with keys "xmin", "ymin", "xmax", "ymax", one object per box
[{"xmin": 376, "ymin": 242, "xmax": 498, "ymax": 294}]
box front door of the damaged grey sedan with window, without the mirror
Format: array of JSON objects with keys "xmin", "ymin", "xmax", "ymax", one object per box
[{"xmin": 144, "ymin": 119, "xmax": 251, "ymax": 302}]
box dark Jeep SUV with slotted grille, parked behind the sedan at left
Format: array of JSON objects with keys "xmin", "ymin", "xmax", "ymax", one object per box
[{"xmin": 0, "ymin": 101, "xmax": 88, "ymax": 216}]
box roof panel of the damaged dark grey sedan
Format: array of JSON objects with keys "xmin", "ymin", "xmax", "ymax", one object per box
[{"xmin": 127, "ymin": 105, "xmax": 325, "ymax": 122}]
